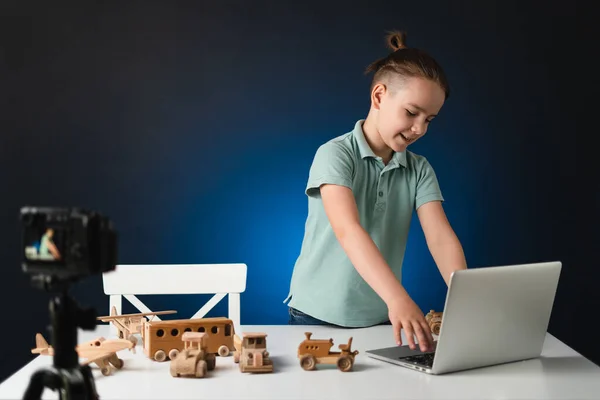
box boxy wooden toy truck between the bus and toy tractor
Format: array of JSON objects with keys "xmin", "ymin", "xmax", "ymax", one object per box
[{"xmin": 233, "ymin": 332, "xmax": 273, "ymax": 372}]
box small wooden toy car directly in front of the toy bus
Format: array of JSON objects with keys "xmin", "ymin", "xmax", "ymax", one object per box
[{"xmin": 170, "ymin": 332, "xmax": 216, "ymax": 378}]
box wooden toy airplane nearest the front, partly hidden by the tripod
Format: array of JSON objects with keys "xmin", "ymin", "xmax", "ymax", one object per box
[{"xmin": 31, "ymin": 333, "xmax": 135, "ymax": 375}]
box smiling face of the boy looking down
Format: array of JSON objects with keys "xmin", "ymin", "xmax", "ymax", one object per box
[{"xmin": 376, "ymin": 78, "xmax": 445, "ymax": 152}]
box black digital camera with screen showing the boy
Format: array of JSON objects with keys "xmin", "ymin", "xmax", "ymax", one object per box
[{"xmin": 20, "ymin": 207, "xmax": 117, "ymax": 281}]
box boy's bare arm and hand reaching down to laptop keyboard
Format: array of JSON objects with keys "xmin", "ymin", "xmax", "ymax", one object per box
[{"xmin": 320, "ymin": 184, "xmax": 433, "ymax": 351}]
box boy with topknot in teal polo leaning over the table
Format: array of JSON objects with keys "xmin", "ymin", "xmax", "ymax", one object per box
[{"xmin": 286, "ymin": 32, "xmax": 467, "ymax": 351}]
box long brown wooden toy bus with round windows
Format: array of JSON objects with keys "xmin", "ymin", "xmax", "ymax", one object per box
[{"xmin": 142, "ymin": 317, "xmax": 235, "ymax": 362}]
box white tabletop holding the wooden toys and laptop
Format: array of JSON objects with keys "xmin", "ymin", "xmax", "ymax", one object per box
[{"xmin": 0, "ymin": 325, "xmax": 600, "ymax": 400}]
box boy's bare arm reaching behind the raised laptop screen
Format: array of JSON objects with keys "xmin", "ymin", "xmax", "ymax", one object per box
[{"xmin": 417, "ymin": 201, "xmax": 467, "ymax": 285}]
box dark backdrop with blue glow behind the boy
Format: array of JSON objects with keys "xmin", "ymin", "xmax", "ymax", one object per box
[{"xmin": 0, "ymin": 1, "xmax": 600, "ymax": 379}]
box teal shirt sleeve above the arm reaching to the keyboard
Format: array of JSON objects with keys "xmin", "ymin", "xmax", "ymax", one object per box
[{"xmin": 306, "ymin": 142, "xmax": 354, "ymax": 197}]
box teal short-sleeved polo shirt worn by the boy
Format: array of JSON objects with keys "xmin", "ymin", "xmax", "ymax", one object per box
[{"xmin": 284, "ymin": 120, "xmax": 444, "ymax": 327}]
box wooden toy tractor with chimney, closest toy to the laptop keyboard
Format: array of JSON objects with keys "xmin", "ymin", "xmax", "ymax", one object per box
[{"xmin": 298, "ymin": 332, "xmax": 358, "ymax": 372}]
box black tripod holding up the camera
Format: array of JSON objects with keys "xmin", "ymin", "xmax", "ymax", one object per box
[{"xmin": 23, "ymin": 278, "xmax": 99, "ymax": 400}]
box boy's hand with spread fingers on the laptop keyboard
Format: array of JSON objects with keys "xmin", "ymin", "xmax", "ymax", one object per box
[{"xmin": 388, "ymin": 295, "xmax": 433, "ymax": 351}]
